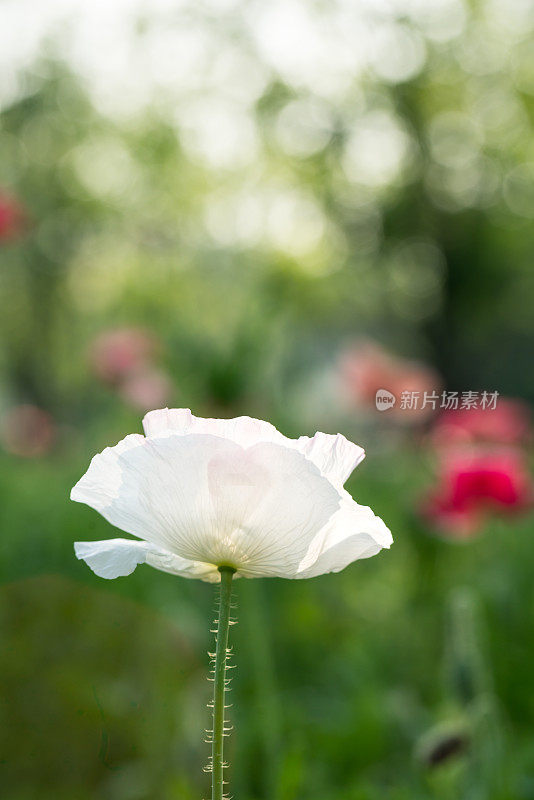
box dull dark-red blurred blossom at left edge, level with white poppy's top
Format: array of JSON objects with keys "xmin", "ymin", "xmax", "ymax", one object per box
[{"xmin": 0, "ymin": 405, "xmax": 56, "ymax": 458}]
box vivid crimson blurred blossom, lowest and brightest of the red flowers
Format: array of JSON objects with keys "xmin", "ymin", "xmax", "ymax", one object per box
[{"xmin": 421, "ymin": 448, "xmax": 534, "ymax": 539}]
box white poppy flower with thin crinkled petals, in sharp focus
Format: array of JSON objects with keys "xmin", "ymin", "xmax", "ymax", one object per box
[{"xmin": 71, "ymin": 408, "xmax": 393, "ymax": 582}]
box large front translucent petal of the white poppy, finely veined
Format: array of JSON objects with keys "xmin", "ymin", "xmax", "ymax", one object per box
[{"xmin": 71, "ymin": 434, "xmax": 340, "ymax": 577}]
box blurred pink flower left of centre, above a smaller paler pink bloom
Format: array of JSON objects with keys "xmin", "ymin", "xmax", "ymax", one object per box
[{"xmin": 89, "ymin": 327, "xmax": 158, "ymax": 385}]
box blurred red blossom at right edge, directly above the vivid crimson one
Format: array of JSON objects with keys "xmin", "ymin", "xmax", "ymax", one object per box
[{"xmin": 431, "ymin": 398, "xmax": 531, "ymax": 447}]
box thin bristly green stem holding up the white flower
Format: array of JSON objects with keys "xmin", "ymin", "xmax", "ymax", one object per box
[{"xmin": 211, "ymin": 567, "xmax": 235, "ymax": 800}]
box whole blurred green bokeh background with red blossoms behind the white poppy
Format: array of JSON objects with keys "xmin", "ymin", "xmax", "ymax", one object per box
[{"xmin": 0, "ymin": 0, "xmax": 534, "ymax": 800}]
